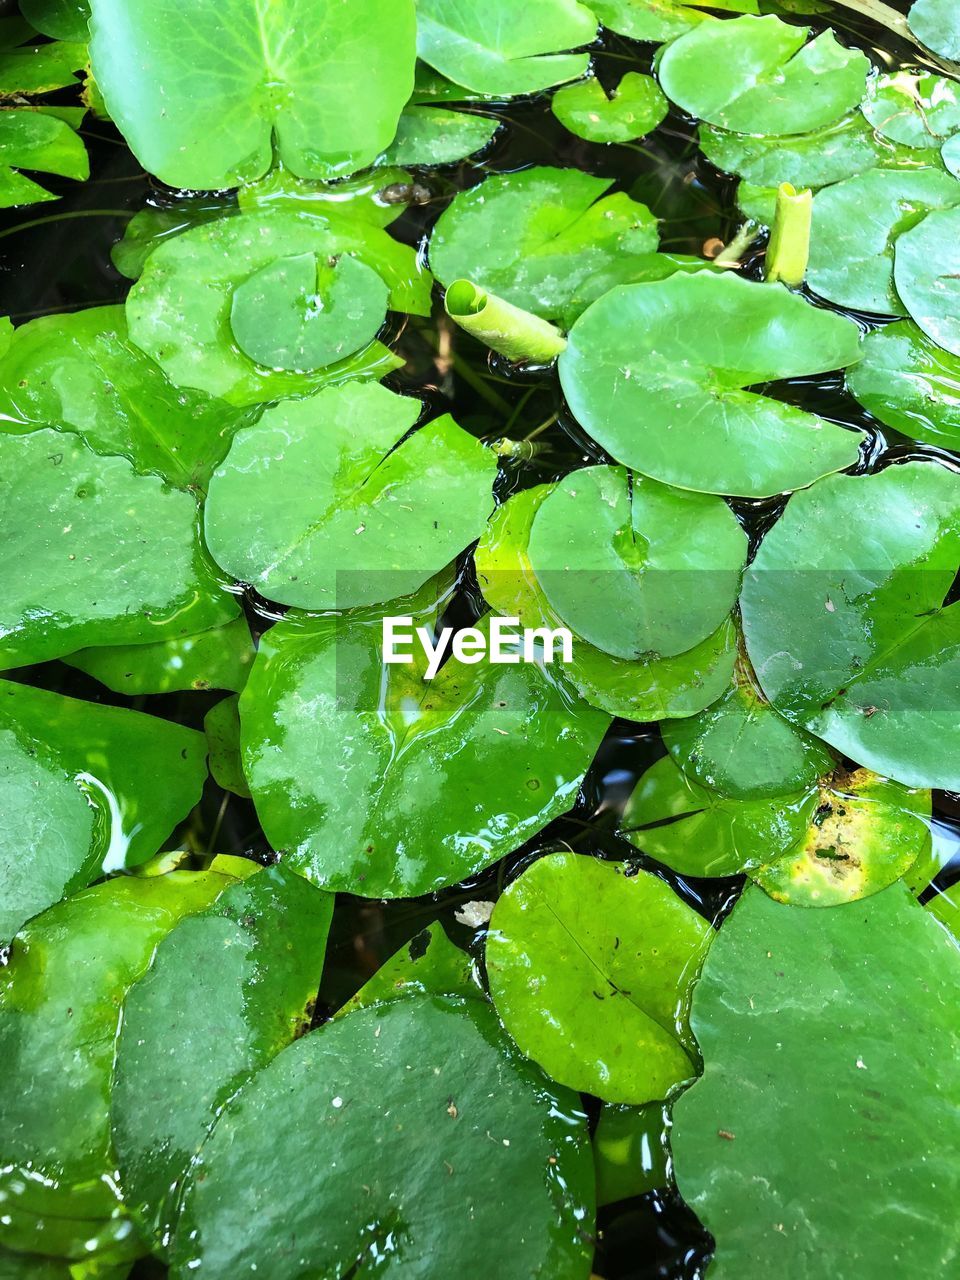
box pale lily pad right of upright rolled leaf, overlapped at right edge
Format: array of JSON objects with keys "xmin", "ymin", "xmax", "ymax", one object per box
[{"xmin": 806, "ymin": 169, "xmax": 960, "ymax": 315}]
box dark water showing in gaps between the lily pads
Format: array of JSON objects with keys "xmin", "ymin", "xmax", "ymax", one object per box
[{"xmin": 0, "ymin": 0, "xmax": 960, "ymax": 1280}]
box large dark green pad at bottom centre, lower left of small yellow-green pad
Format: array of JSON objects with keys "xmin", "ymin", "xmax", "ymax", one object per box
[{"xmin": 172, "ymin": 997, "xmax": 594, "ymax": 1280}]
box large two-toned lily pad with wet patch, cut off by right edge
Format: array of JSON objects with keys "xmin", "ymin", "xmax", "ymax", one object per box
[{"xmin": 741, "ymin": 462, "xmax": 960, "ymax": 790}]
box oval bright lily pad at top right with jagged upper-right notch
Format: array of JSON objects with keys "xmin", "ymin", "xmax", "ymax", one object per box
[{"xmin": 658, "ymin": 15, "xmax": 870, "ymax": 134}]
